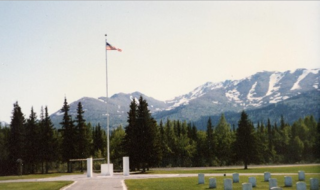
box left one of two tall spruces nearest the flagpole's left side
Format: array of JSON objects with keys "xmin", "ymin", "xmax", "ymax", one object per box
[{"xmin": 60, "ymin": 98, "xmax": 77, "ymax": 173}]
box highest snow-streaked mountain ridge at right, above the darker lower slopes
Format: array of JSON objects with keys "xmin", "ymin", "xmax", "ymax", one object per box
[{"xmin": 166, "ymin": 69, "xmax": 320, "ymax": 110}]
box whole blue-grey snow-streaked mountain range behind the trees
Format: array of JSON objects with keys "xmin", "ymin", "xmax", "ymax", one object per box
[{"xmin": 51, "ymin": 69, "xmax": 320, "ymax": 127}]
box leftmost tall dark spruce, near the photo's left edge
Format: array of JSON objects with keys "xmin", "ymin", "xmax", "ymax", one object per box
[{"xmin": 8, "ymin": 102, "xmax": 25, "ymax": 172}]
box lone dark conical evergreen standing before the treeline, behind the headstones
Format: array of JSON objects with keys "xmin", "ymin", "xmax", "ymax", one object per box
[{"xmin": 234, "ymin": 111, "xmax": 259, "ymax": 169}]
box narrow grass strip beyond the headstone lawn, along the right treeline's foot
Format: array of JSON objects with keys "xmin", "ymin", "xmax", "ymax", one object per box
[{"xmin": 146, "ymin": 165, "xmax": 320, "ymax": 174}]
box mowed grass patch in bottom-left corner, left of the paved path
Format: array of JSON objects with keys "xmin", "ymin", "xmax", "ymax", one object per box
[{"xmin": 0, "ymin": 181, "xmax": 73, "ymax": 190}]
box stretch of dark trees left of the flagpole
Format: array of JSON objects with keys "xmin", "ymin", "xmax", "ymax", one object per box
[{"xmin": 0, "ymin": 99, "xmax": 106, "ymax": 175}]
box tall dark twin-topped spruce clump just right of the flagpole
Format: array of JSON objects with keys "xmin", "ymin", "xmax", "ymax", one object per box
[{"xmin": 124, "ymin": 96, "xmax": 162, "ymax": 172}]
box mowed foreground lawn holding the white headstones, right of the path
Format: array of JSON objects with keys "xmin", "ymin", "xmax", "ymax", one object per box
[{"xmin": 125, "ymin": 174, "xmax": 320, "ymax": 190}]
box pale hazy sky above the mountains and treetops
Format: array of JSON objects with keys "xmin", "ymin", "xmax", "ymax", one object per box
[{"xmin": 0, "ymin": 1, "xmax": 320, "ymax": 123}]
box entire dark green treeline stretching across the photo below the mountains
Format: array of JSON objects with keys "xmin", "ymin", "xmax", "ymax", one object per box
[{"xmin": 0, "ymin": 97, "xmax": 320, "ymax": 175}]
